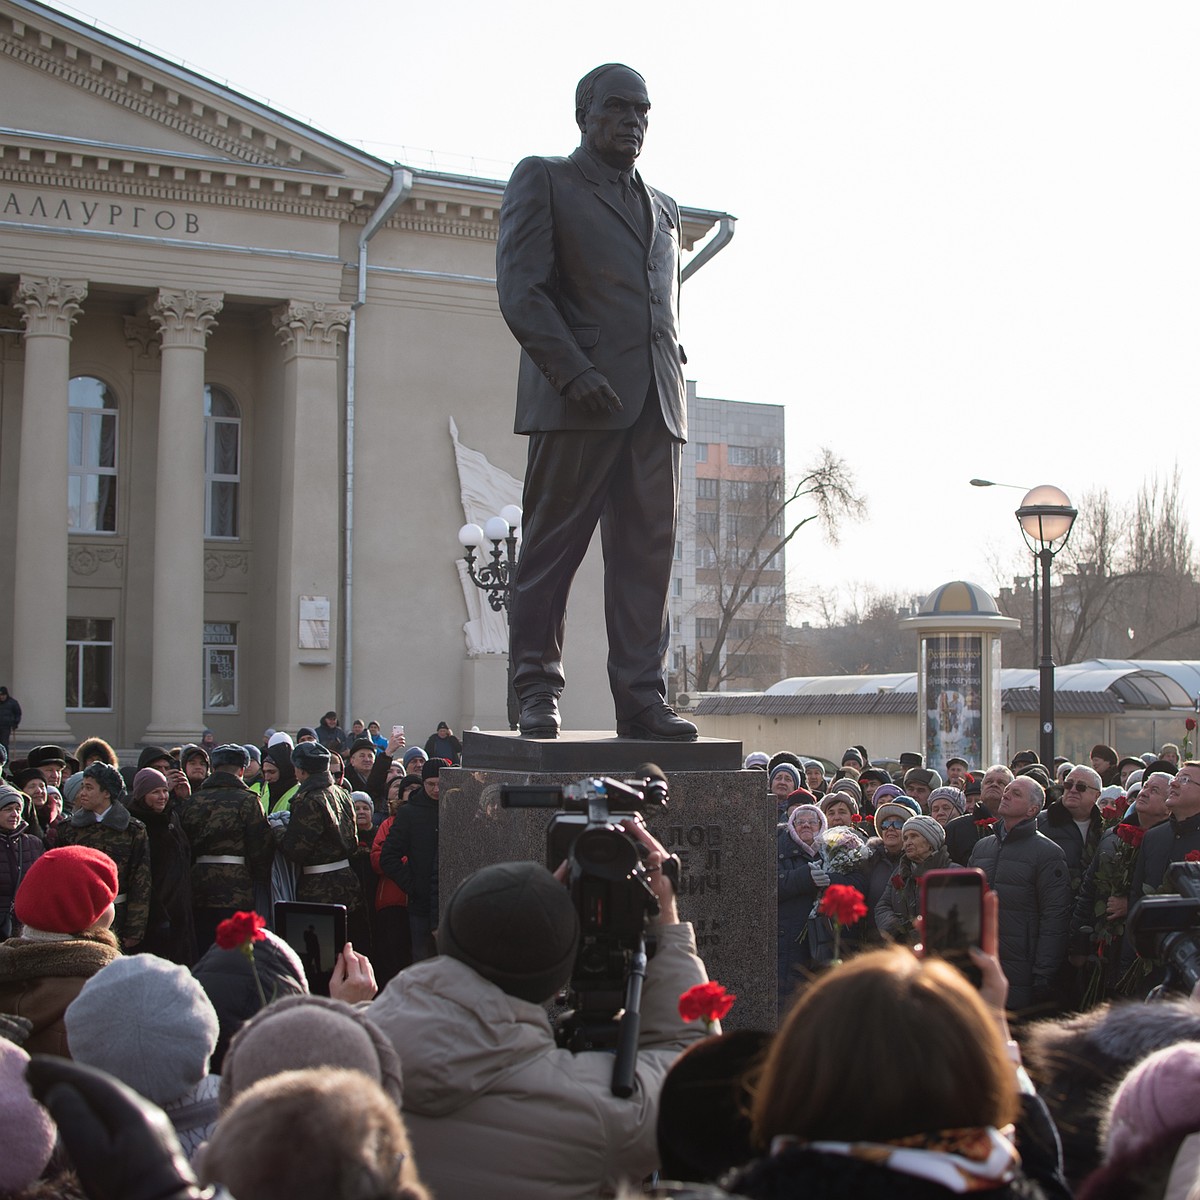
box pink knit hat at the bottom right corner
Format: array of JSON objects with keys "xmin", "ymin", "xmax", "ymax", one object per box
[{"xmin": 1104, "ymin": 1042, "xmax": 1200, "ymax": 1162}]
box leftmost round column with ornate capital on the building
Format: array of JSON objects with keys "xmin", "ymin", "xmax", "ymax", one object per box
[{"xmin": 8, "ymin": 275, "xmax": 88, "ymax": 745}]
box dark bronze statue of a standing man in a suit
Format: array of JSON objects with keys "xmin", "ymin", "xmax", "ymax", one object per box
[{"xmin": 496, "ymin": 62, "xmax": 696, "ymax": 742}]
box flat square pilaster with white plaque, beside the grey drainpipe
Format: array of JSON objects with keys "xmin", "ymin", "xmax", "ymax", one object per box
[{"xmin": 271, "ymin": 300, "xmax": 350, "ymax": 728}]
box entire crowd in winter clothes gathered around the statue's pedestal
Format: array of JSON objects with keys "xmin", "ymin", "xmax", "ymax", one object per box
[{"xmin": 0, "ymin": 714, "xmax": 1200, "ymax": 1200}]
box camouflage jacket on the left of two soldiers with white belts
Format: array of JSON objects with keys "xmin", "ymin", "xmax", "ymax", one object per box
[{"xmin": 179, "ymin": 770, "xmax": 275, "ymax": 910}]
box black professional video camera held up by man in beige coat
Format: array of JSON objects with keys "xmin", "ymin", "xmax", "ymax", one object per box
[{"xmin": 500, "ymin": 763, "xmax": 679, "ymax": 1096}]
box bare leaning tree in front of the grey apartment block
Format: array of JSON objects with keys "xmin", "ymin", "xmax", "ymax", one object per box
[{"xmin": 692, "ymin": 449, "xmax": 865, "ymax": 691}]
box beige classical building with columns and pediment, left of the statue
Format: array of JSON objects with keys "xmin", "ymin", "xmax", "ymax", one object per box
[{"xmin": 0, "ymin": 0, "xmax": 728, "ymax": 746}]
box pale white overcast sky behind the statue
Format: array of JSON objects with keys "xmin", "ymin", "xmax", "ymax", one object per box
[{"xmin": 59, "ymin": 0, "xmax": 1200, "ymax": 619}]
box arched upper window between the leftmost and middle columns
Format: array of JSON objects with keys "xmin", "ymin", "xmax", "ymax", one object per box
[{"xmin": 67, "ymin": 376, "xmax": 116, "ymax": 533}]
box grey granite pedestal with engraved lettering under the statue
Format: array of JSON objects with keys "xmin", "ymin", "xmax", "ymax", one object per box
[{"xmin": 439, "ymin": 734, "xmax": 776, "ymax": 1030}]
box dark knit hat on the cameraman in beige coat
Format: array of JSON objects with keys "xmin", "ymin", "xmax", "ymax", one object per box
[{"xmin": 438, "ymin": 863, "xmax": 580, "ymax": 1004}]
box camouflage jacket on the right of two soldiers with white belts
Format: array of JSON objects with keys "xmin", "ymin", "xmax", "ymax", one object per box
[{"xmin": 280, "ymin": 772, "xmax": 364, "ymax": 912}]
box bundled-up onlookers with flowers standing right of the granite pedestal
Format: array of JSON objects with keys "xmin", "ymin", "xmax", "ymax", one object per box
[{"xmin": 763, "ymin": 743, "xmax": 1200, "ymax": 1018}]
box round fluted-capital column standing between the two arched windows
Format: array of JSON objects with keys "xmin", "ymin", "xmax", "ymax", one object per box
[{"xmin": 142, "ymin": 290, "xmax": 223, "ymax": 745}]
